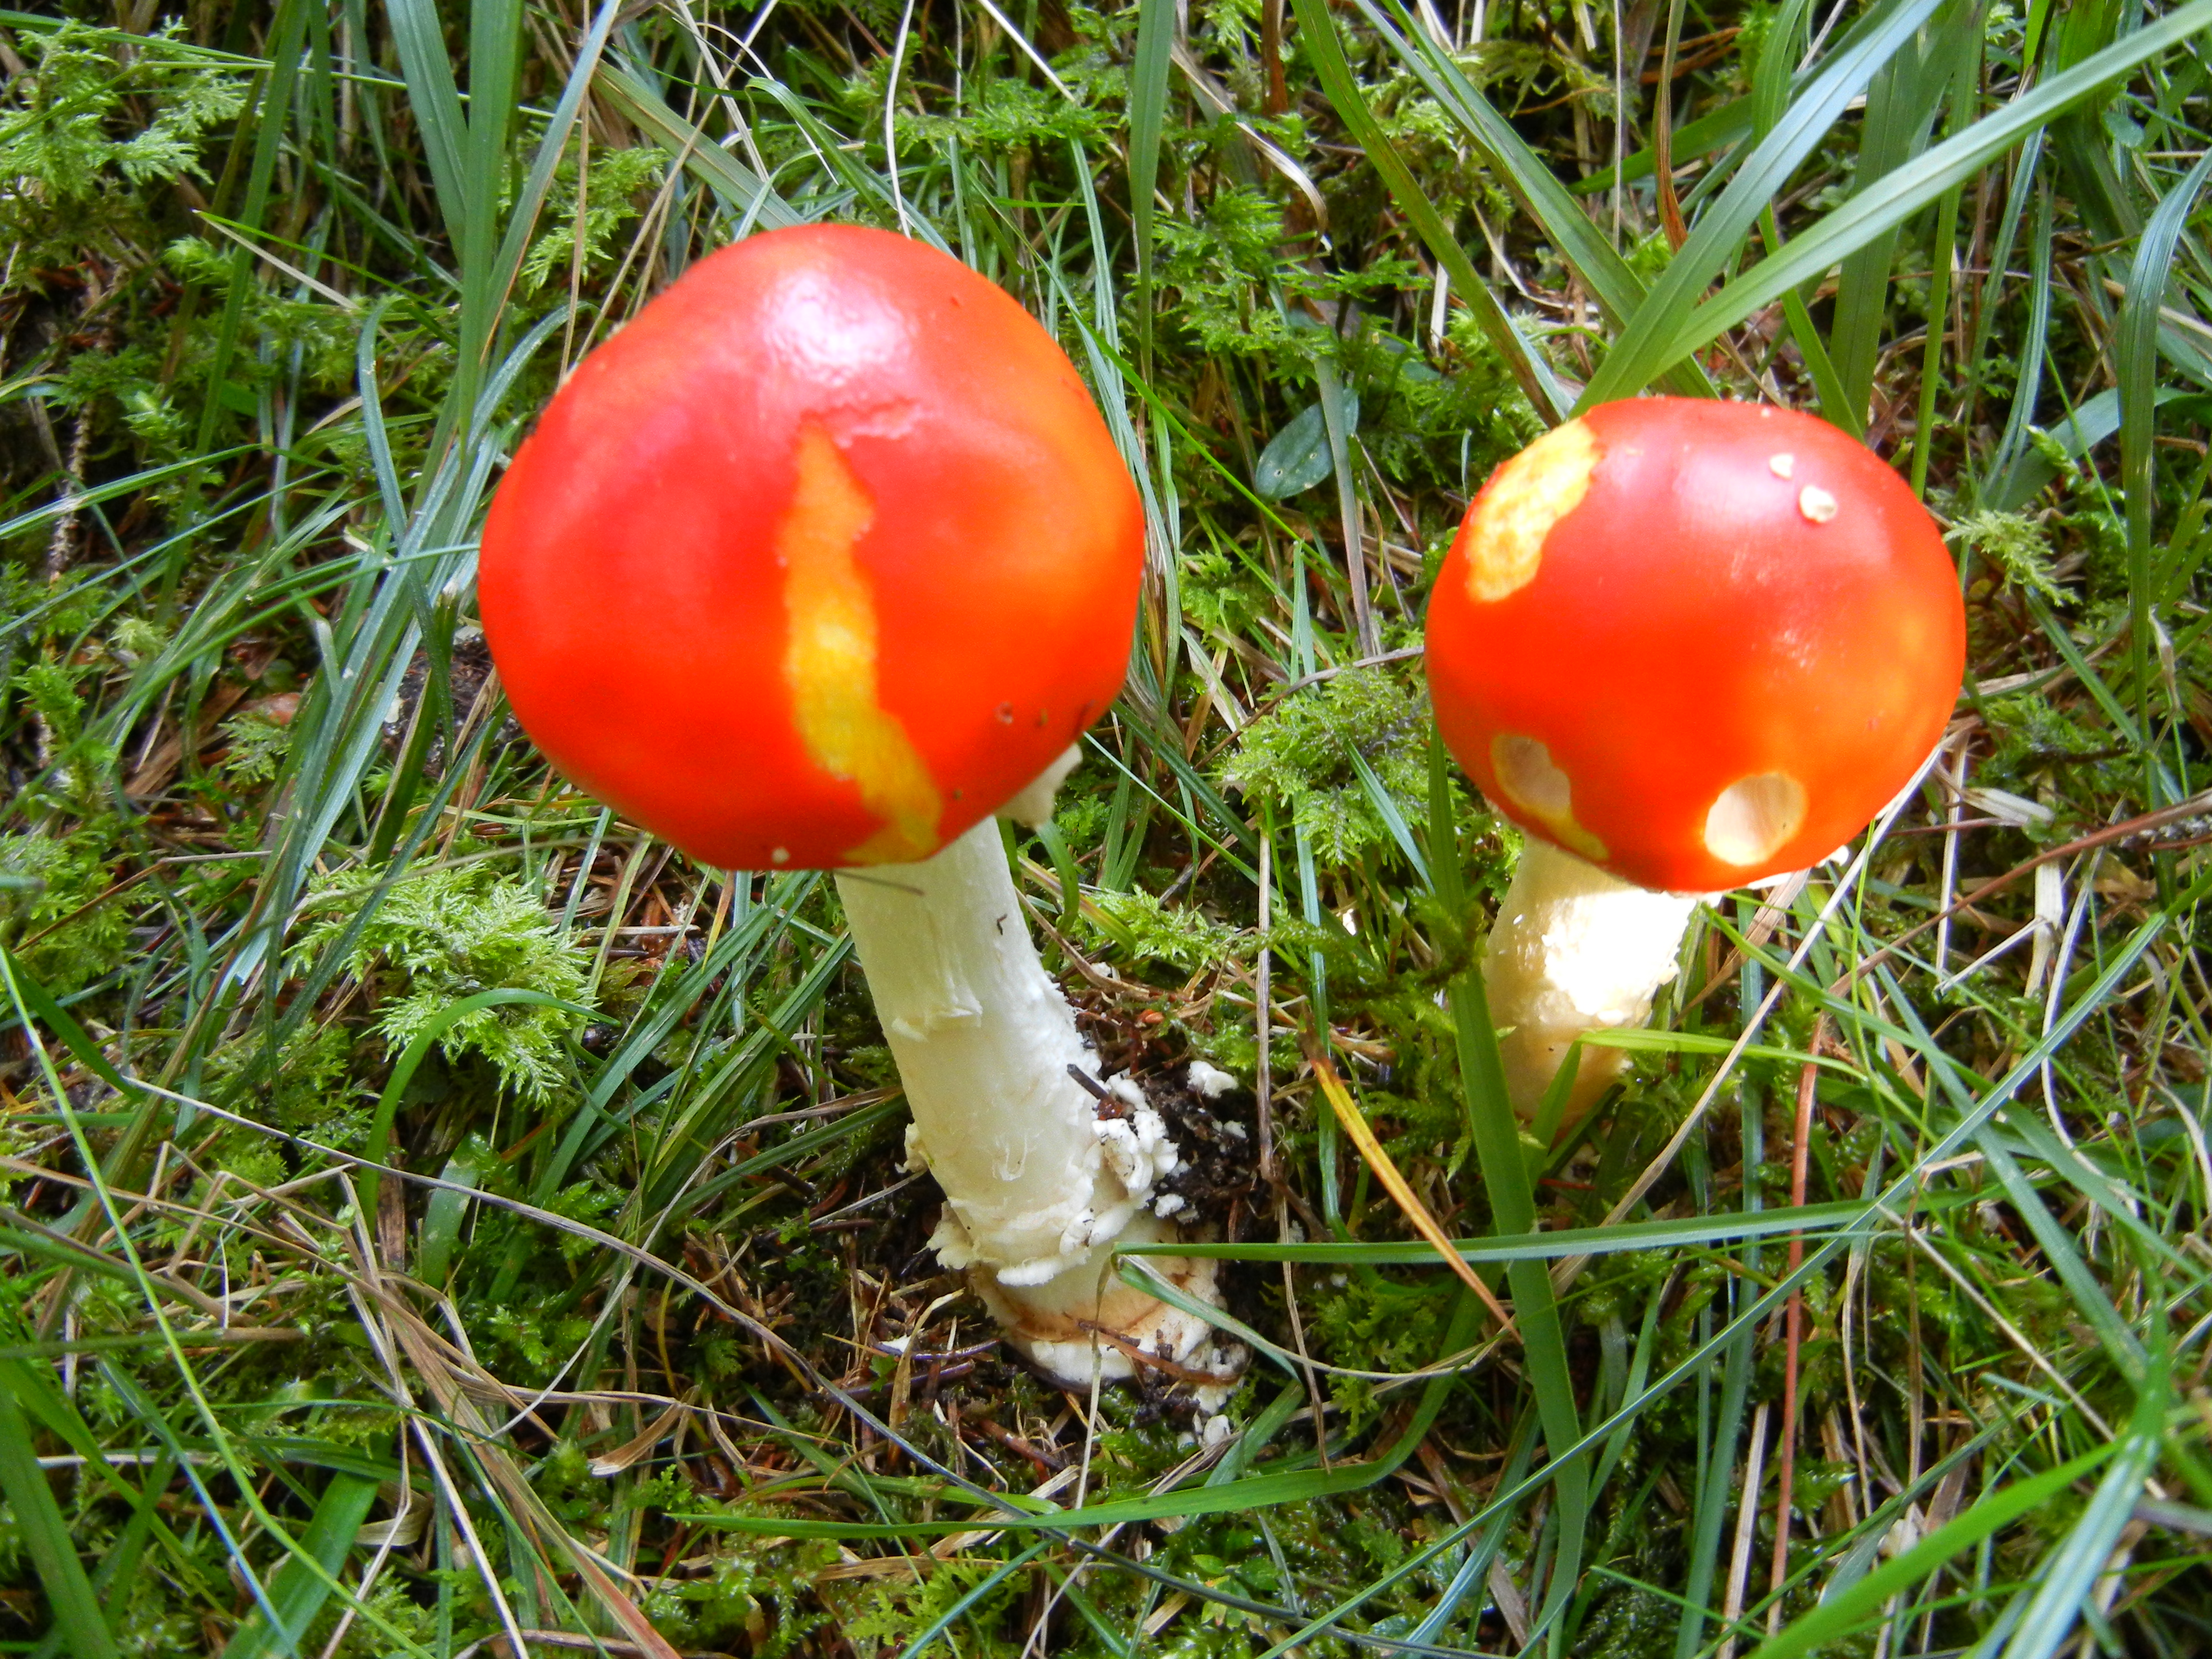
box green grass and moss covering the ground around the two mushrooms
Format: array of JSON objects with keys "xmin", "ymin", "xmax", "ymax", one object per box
[{"xmin": 0, "ymin": 0, "xmax": 2212, "ymax": 1659}]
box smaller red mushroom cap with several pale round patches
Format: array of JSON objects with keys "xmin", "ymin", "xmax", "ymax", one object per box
[{"xmin": 1429, "ymin": 398, "xmax": 1966, "ymax": 894}]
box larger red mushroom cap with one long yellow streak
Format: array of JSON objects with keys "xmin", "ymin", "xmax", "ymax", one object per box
[{"xmin": 478, "ymin": 226, "xmax": 1144, "ymax": 869}]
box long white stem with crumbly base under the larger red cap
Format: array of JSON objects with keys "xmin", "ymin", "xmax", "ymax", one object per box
[{"xmin": 838, "ymin": 779, "xmax": 1214, "ymax": 1383}]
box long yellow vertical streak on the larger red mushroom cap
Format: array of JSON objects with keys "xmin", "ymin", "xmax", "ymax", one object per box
[{"xmin": 776, "ymin": 427, "xmax": 945, "ymax": 865}]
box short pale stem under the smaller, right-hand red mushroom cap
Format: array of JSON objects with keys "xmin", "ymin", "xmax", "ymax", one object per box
[{"xmin": 1482, "ymin": 836, "xmax": 1701, "ymax": 1126}]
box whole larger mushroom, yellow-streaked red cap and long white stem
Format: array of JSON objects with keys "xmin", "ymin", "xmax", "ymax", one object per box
[{"xmin": 478, "ymin": 226, "xmax": 1212, "ymax": 1378}]
